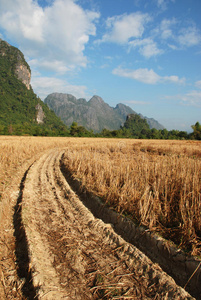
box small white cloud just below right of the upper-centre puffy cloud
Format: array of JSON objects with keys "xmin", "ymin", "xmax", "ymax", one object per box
[{"xmin": 129, "ymin": 38, "xmax": 163, "ymax": 58}]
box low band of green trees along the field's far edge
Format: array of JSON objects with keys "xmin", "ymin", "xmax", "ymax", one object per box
[{"xmin": 0, "ymin": 115, "xmax": 201, "ymax": 140}]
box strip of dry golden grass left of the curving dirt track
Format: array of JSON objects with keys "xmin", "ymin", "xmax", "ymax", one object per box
[{"xmin": 0, "ymin": 136, "xmax": 73, "ymax": 300}]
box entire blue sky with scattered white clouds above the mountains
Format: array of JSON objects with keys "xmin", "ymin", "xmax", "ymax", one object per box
[{"xmin": 0, "ymin": 0, "xmax": 201, "ymax": 132}]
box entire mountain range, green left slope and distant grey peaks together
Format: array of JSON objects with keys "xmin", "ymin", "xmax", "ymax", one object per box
[{"xmin": 0, "ymin": 39, "xmax": 164, "ymax": 135}]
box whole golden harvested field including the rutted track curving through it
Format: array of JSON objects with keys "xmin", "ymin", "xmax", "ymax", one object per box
[{"xmin": 0, "ymin": 136, "xmax": 201, "ymax": 300}]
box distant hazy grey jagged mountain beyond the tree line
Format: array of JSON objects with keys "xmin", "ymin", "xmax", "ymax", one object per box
[{"xmin": 44, "ymin": 93, "xmax": 164, "ymax": 132}]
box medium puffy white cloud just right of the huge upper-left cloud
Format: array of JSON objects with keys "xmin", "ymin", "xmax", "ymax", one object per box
[{"xmin": 99, "ymin": 12, "xmax": 151, "ymax": 44}]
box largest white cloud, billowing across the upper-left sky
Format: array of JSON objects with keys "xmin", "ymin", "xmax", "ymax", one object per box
[{"xmin": 0, "ymin": 0, "xmax": 99, "ymax": 70}]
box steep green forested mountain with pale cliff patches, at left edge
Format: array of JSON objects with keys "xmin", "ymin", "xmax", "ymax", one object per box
[{"xmin": 0, "ymin": 39, "xmax": 65, "ymax": 134}]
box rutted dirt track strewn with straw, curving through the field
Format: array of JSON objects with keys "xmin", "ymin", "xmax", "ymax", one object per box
[{"xmin": 15, "ymin": 150, "xmax": 193, "ymax": 300}]
